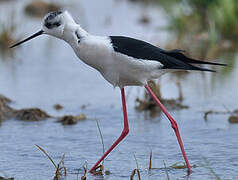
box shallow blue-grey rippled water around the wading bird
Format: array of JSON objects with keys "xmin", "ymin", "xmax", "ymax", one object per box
[{"xmin": 0, "ymin": 0, "xmax": 238, "ymax": 180}]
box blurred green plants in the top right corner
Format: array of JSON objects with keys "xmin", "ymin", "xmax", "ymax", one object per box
[{"xmin": 165, "ymin": 0, "xmax": 238, "ymax": 51}]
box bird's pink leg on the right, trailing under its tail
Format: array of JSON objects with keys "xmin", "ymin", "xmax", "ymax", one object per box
[{"xmin": 145, "ymin": 85, "xmax": 192, "ymax": 174}]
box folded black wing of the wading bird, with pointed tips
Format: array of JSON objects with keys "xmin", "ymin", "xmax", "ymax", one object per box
[{"xmin": 109, "ymin": 36, "xmax": 225, "ymax": 72}]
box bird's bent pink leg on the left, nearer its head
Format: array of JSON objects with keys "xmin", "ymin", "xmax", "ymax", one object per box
[{"xmin": 89, "ymin": 88, "xmax": 129, "ymax": 172}]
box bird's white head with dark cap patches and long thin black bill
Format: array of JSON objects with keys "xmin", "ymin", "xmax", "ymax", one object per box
[{"xmin": 10, "ymin": 11, "xmax": 75, "ymax": 48}]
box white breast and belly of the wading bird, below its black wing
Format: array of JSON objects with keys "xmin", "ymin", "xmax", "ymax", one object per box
[{"xmin": 74, "ymin": 36, "xmax": 165, "ymax": 87}]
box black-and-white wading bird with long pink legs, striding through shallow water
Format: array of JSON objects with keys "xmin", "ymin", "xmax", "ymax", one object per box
[{"xmin": 10, "ymin": 10, "xmax": 226, "ymax": 173}]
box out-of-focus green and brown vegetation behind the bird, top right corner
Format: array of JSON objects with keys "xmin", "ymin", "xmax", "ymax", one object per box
[{"xmin": 159, "ymin": 0, "xmax": 238, "ymax": 58}]
